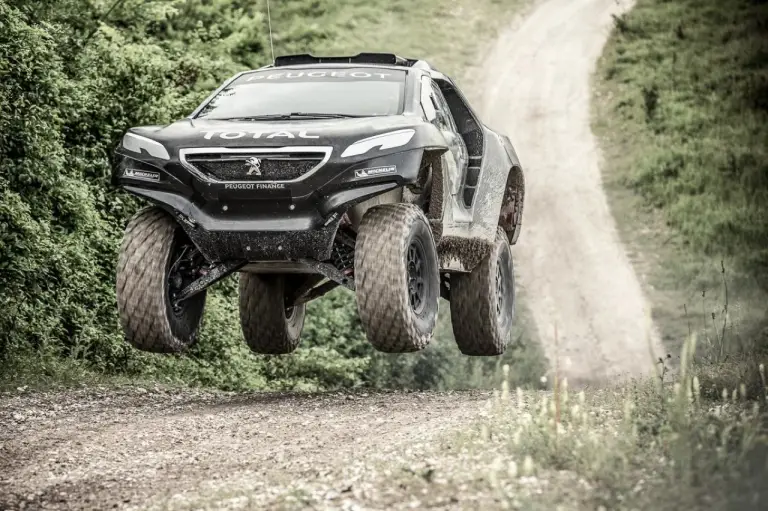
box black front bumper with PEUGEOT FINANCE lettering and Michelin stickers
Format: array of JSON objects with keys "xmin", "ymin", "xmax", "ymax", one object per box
[{"xmin": 115, "ymin": 149, "xmax": 423, "ymax": 262}]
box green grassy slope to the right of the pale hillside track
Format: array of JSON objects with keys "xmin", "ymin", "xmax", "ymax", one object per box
[{"xmin": 593, "ymin": 0, "xmax": 768, "ymax": 361}]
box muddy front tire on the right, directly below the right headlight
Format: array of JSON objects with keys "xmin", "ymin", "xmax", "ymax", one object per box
[{"xmin": 355, "ymin": 204, "xmax": 440, "ymax": 353}]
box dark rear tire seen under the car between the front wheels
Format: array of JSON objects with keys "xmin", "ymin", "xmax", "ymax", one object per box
[{"xmin": 240, "ymin": 273, "xmax": 306, "ymax": 355}]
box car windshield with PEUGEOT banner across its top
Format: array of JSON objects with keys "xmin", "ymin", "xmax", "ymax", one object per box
[{"xmin": 196, "ymin": 67, "xmax": 405, "ymax": 120}]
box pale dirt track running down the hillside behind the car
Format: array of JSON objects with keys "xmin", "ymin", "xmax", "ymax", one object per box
[{"xmin": 483, "ymin": 0, "xmax": 662, "ymax": 383}]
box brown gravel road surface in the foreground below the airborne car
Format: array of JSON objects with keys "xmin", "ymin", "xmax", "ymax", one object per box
[{"xmin": 0, "ymin": 387, "xmax": 487, "ymax": 510}]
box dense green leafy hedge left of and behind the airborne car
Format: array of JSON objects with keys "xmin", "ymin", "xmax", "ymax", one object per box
[{"xmin": 0, "ymin": 0, "xmax": 540, "ymax": 389}]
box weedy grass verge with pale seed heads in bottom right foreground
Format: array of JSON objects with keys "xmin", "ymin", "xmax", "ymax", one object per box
[{"xmin": 380, "ymin": 360, "xmax": 768, "ymax": 511}]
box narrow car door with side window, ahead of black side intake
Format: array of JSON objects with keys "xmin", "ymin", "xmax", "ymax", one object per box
[{"xmin": 422, "ymin": 76, "xmax": 469, "ymax": 195}]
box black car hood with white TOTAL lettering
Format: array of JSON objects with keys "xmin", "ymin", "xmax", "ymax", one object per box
[{"xmin": 129, "ymin": 115, "xmax": 431, "ymax": 156}]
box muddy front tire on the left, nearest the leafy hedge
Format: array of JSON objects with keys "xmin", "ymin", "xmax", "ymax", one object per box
[{"xmin": 116, "ymin": 207, "xmax": 206, "ymax": 353}]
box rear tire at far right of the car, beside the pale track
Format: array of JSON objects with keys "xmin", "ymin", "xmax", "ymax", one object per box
[{"xmin": 451, "ymin": 227, "xmax": 515, "ymax": 356}]
